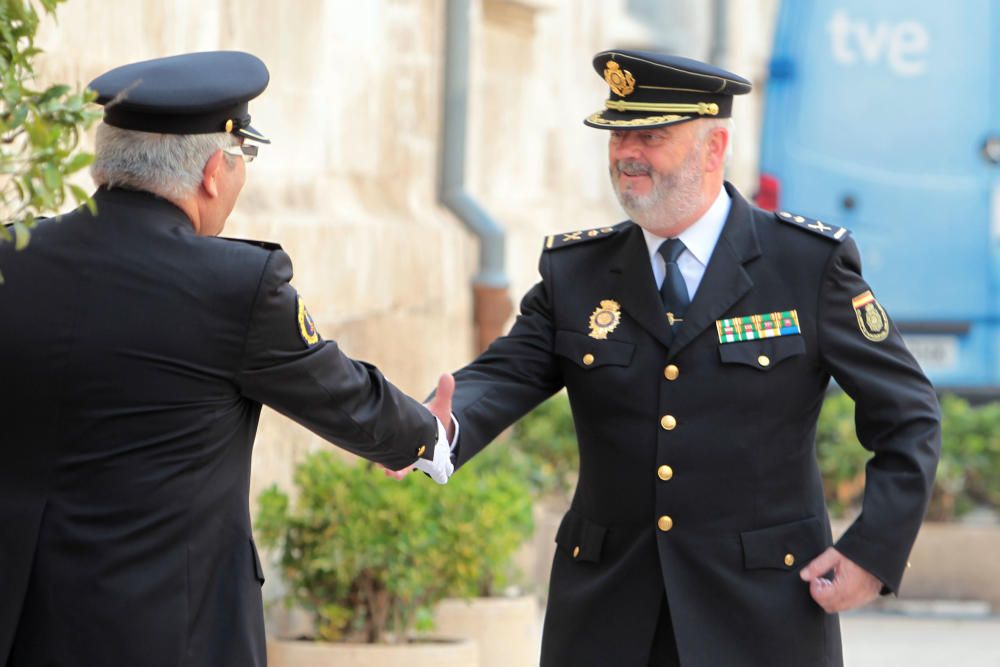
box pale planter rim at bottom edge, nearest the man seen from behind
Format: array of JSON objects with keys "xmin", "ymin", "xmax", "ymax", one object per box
[{"xmin": 267, "ymin": 639, "xmax": 479, "ymax": 667}]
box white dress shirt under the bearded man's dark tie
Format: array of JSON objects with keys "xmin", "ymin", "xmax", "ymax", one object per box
[{"xmin": 642, "ymin": 188, "xmax": 733, "ymax": 299}]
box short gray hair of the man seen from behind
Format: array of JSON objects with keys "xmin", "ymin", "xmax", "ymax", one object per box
[{"xmin": 90, "ymin": 123, "xmax": 239, "ymax": 201}]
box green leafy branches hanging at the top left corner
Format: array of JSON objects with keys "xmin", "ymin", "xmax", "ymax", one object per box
[{"xmin": 0, "ymin": 0, "xmax": 100, "ymax": 272}]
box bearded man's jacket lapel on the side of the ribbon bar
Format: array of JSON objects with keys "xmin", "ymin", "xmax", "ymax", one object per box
[{"xmin": 668, "ymin": 183, "xmax": 761, "ymax": 357}]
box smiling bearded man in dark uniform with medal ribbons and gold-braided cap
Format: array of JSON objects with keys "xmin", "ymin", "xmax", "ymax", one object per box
[{"xmin": 439, "ymin": 51, "xmax": 940, "ymax": 667}]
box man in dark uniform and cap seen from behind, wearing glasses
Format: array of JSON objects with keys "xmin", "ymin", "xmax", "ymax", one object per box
[{"xmin": 0, "ymin": 52, "xmax": 449, "ymax": 667}]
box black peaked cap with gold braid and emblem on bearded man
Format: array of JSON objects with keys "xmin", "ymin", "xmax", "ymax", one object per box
[{"xmin": 583, "ymin": 50, "xmax": 752, "ymax": 130}]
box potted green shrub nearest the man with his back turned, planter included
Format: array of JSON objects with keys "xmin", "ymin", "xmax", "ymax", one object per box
[{"xmin": 255, "ymin": 451, "xmax": 478, "ymax": 667}]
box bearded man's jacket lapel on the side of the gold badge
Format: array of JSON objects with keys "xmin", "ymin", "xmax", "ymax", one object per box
[{"xmin": 611, "ymin": 224, "xmax": 673, "ymax": 347}]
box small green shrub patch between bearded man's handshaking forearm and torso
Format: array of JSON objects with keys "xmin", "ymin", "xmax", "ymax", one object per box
[{"xmin": 508, "ymin": 392, "xmax": 580, "ymax": 496}]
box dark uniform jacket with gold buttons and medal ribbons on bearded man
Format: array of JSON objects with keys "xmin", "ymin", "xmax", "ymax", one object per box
[{"xmin": 454, "ymin": 184, "xmax": 940, "ymax": 667}]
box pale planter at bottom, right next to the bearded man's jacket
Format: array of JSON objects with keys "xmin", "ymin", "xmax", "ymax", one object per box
[{"xmin": 434, "ymin": 595, "xmax": 540, "ymax": 667}]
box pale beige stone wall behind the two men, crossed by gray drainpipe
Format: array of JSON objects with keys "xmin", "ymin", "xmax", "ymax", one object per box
[{"xmin": 33, "ymin": 0, "xmax": 775, "ymax": 496}]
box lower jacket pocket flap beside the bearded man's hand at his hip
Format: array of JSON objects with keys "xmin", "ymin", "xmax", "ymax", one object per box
[{"xmin": 740, "ymin": 517, "xmax": 827, "ymax": 570}]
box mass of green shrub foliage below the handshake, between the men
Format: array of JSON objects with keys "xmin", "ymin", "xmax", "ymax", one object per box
[{"xmin": 256, "ymin": 448, "xmax": 534, "ymax": 642}]
